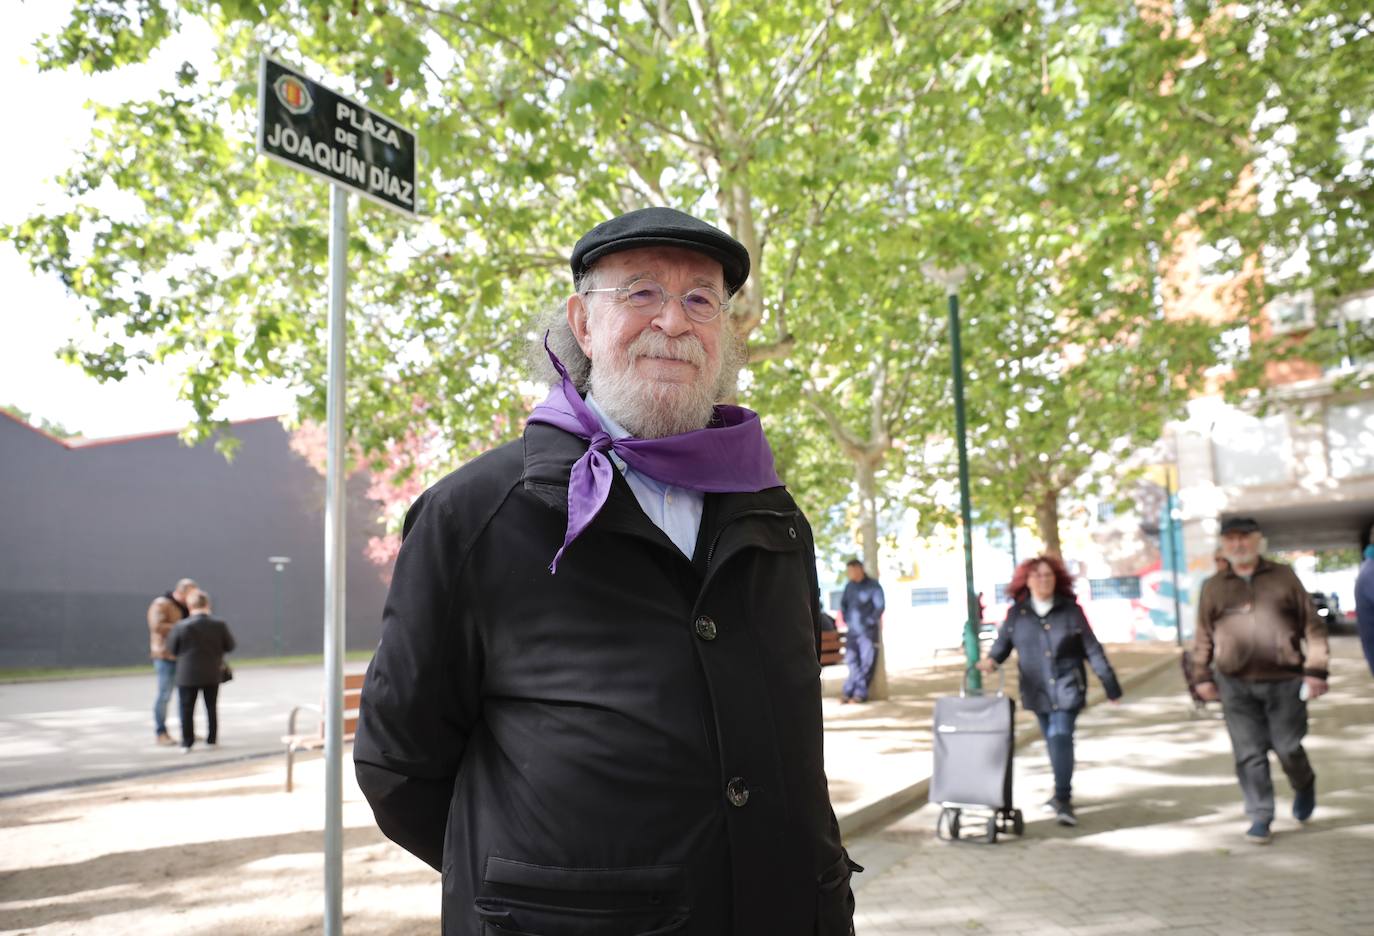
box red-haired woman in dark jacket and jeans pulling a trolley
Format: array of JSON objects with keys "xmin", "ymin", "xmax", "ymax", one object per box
[{"xmin": 978, "ymin": 555, "xmax": 1121, "ymax": 826}]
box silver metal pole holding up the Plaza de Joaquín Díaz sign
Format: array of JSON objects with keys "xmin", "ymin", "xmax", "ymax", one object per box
[{"xmin": 324, "ymin": 184, "xmax": 348, "ymax": 936}]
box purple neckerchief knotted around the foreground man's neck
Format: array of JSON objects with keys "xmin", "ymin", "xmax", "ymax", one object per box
[{"xmin": 529, "ymin": 335, "xmax": 782, "ymax": 572}]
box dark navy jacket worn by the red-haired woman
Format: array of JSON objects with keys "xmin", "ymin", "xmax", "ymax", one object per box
[{"xmin": 988, "ymin": 595, "xmax": 1121, "ymax": 715}]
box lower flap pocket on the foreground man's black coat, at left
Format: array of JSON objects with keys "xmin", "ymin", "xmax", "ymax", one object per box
[{"xmin": 474, "ymin": 858, "xmax": 691, "ymax": 936}]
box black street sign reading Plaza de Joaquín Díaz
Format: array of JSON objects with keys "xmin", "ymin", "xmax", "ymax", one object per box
[{"xmin": 258, "ymin": 55, "xmax": 416, "ymax": 217}]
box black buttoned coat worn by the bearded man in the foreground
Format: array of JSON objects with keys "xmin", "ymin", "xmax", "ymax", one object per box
[{"xmin": 353, "ymin": 425, "xmax": 853, "ymax": 936}]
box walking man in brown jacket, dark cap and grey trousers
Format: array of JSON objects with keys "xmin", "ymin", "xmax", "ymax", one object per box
[{"xmin": 1193, "ymin": 517, "xmax": 1329, "ymax": 845}]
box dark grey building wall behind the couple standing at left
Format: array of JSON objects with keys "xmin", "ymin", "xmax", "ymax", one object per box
[{"xmin": 0, "ymin": 414, "xmax": 387, "ymax": 667}]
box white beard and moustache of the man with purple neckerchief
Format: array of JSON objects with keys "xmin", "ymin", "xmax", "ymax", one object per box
[{"xmin": 591, "ymin": 326, "xmax": 720, "ymax": 438}]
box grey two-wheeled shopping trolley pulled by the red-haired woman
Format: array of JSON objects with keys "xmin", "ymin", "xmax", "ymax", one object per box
[{"xmin": 930, "ymin": 667, "xmax": 1025, "ymax": 843}]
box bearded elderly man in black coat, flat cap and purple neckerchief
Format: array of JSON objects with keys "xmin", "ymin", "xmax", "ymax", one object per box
[{"xmin": 354, "ymin": 208, "xmax": 861, "ymax": 936}]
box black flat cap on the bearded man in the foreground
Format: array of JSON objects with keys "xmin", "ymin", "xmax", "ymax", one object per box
[{"xmin": 572, "ymin": 208, "xmax": 749, "ymax": 294}]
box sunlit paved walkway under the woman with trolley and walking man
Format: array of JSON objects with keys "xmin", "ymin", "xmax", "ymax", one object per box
[{"xmin": 851, "ymin": 638, "xmax": 1374, "ymax": 936}]
